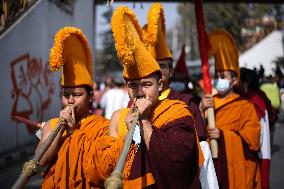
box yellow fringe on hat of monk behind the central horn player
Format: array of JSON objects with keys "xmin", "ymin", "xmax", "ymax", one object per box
[{"xmin": 146, "ymin": 3, "xmax": 166, "ymax": 46}]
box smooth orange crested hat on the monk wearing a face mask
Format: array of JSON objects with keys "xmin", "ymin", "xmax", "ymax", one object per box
[{"xmin": 209, "ymin": 29, "xmax": 240, "ymax": 78}]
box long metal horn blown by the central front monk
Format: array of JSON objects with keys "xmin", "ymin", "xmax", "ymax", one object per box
[{"xmin": 104, "ymin": 109, "xmax": 139, "ymax": 189}]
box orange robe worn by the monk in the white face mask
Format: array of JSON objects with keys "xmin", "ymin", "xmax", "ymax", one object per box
[{"xmin": 214, "ymin": 94, "xmax": 261, "ymax": 189}]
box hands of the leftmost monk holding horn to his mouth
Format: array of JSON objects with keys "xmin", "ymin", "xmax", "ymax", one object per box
[{"xmin": 60, "ymin": 106, "xmax": 77, "ymax": 130}]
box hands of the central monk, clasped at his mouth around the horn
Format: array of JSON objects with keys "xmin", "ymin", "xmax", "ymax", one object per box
[{"xmin": 134, "ymin": 98, "xmax": 152, "ymax": 120}]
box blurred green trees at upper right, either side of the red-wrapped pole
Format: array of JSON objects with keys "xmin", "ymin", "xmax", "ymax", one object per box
[{"xmin": 177, "ymin": 3, "xmax": 281, "ymax": 59}]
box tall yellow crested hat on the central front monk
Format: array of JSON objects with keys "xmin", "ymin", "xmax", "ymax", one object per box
[{"xmin": 111, "ymin": 6, "xmax": 160, "ymax": 79}]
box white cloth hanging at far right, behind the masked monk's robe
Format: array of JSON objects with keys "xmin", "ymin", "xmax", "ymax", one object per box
[{"xmin": 258, "ymin": 110, "xmax": 271, "ymax": 159}]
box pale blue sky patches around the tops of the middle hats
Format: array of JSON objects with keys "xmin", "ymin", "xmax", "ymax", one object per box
[{"xmin": 96, "ymin": 2, "xmax": 179, "ymax": 48}]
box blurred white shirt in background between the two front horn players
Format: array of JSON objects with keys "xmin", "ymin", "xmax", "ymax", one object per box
[{"xmin": 100, "ymin": 88, "xmax": 129, "ymax": 119}]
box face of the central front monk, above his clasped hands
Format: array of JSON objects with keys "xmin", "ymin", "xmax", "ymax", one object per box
[{"xmin": 126, "ymin": 74, "xmax": 163, "ymax": 104}]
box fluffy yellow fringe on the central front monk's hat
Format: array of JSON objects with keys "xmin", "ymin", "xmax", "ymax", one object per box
[{"xmin": 111, "ymin": 6, "xmax": 143, "ymax": 66}]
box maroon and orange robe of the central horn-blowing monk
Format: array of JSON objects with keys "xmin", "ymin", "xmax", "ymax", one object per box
[{"xmin": 118, "ymin": 99, "xmax": 203, "ymax": 189}]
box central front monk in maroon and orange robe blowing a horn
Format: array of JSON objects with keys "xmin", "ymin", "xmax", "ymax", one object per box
[{"xmin": 109, "ymin": 7, "xmax": 202, "ymax": 189}]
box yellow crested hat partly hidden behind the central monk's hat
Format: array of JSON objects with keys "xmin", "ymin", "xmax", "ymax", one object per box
[{"xmin": 143, "ymin": 3, "xmax": 173, "ymax": 60}]
